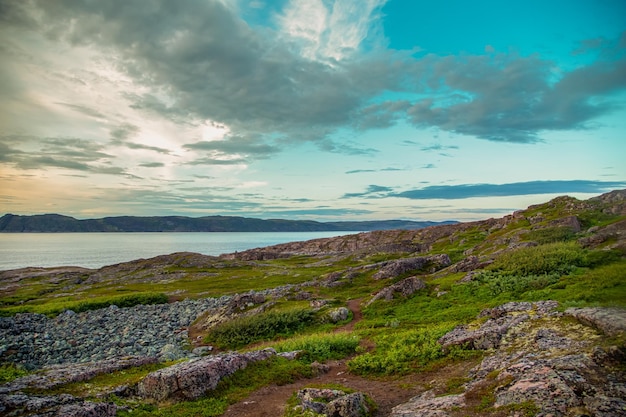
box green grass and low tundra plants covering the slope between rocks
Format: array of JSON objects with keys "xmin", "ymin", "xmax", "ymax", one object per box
[{"xmin": 0, "ymin": 191, "xmax": 626, "ymax": 417}]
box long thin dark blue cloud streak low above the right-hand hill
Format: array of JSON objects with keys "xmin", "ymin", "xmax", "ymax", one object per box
[{"xmin": 394, "ymin": 180, "xmax": 626, "ymax": 200}]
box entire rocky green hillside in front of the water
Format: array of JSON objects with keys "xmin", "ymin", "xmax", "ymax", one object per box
[{"xmin": 0, "ymin": 190, "xmax": 626, "ymax": 417}]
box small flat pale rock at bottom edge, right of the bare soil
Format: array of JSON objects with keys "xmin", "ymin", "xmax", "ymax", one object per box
[{"xmin": 389, "ymin": 390, "xmax": 465, "ymax": 417}]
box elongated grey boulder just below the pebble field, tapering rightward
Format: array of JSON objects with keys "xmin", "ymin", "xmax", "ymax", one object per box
[{"xmin": 137, "ymin": 348, "xmax": 276, "ymax": 401}]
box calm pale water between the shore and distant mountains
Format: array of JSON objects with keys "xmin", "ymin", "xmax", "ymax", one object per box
[{"xmin": 0, "ymin": 232, "xmax": 356, "ymax": 270}]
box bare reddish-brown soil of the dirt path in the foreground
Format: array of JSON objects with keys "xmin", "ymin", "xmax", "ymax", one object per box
[{"xmin": 217, "ymin": 300, "xmax": 476, "ymax": 417}]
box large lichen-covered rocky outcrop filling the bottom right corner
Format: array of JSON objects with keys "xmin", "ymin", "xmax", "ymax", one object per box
[{"xmin": 391, "ymin": 301, "xmax": 626, "ymax": 417}]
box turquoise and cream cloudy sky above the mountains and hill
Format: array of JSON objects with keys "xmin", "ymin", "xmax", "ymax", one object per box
[{"xmin": 0, "ymin": 0, "xmax": 626, "ymax": 221}]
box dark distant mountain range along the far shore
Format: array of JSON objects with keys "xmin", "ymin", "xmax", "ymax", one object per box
[{"xmin": 0, "ymin": 214, "xmax": 457, "ymax": 233}]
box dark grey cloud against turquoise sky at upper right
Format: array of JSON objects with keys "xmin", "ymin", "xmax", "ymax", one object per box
[{"xmin": 408, "ymin": 49, "xmax": 626, "ymax": 143}]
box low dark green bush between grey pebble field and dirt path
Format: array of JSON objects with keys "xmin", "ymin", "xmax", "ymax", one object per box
[{"xmin": 204, "ymin": 309, "xmax": 314, "ymax": 349}]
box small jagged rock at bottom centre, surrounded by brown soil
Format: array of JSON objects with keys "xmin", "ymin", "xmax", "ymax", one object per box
[{"xmin": 296, "ymin": 388, "xmax": 370, "ymax": 417}]
